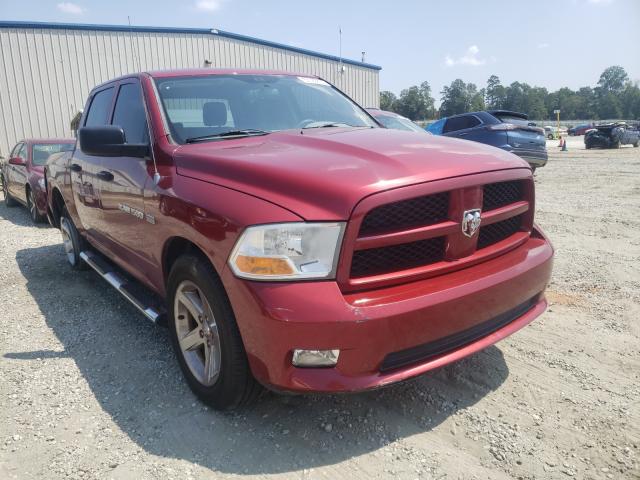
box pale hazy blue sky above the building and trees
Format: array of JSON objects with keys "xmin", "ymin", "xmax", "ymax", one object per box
[{"xmin": 0, "ymin": 0, "xmax": 640, "ymax": 99}]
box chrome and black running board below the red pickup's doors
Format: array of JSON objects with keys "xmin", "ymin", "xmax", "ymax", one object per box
[{"xmin": 80, "ymin": 251, "xmax": 164, "ymax": 323}]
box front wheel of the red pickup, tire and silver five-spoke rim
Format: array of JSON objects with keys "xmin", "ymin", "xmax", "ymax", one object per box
[{"xmin": 167, "ymin": 254, "xmax": 261, "ymax": 410}]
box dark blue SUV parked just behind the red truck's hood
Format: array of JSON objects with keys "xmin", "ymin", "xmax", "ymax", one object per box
[{"xmin": 427, "ymin": 110, "xmax": 547, "ymax": 171}]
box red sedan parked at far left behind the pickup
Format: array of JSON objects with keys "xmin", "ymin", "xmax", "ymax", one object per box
[{"xmin": 0, "ymin": 139, "xmax": 75, "ymax": 223}]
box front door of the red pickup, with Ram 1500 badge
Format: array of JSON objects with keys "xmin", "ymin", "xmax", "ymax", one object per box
[{"xmin": 98, "ymin": 79, "xmax": 151, "ymax": 270}]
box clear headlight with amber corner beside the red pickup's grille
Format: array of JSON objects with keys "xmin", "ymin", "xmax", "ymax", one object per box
[{"xmin": 229, "ymin": 222, "xmax": 345, "ymax": 280}]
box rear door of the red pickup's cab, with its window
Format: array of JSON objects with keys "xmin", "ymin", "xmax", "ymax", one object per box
[{"xmin": 69, "ymin": 85, "xmax": 115, "ymax": 237}]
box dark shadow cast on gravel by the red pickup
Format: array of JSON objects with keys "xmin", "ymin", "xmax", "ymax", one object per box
[{"xmin": 6, "ymin": 245, "xmax": 508, "ymax": 474}]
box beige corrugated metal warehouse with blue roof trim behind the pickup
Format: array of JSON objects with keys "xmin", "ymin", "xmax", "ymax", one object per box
[{"xmin": 0, "ymin": 22, "xmax": 380, "ymax": 157}]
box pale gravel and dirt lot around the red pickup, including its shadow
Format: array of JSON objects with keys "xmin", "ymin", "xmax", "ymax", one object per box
[{"xmin": 0, "ymin": 137, "xmax": 640, "ymax": 479}]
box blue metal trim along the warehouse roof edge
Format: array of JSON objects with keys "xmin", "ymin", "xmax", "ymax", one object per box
[{"xmin": 0, "ymin": 21, "xmax": 382, "ymax": 70}]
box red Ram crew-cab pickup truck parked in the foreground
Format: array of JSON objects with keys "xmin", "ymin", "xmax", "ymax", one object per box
[{"xmin": 46, "ymin": 69, "xmax": 553, "ymax": 408}]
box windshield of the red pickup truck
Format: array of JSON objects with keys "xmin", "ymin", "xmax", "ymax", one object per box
[{"xmin": 155, "ymin": 74, "xmax": 376, "ymax": 143}]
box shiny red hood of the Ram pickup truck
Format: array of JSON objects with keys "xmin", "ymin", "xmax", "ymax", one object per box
[{"xmin": 174, "ymin": 128, "xmax": 528, "ymax": 220}]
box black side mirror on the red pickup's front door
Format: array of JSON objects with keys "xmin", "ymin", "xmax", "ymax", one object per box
[{"xmin": 78, "ymin": 125, "xmax": 149, "ymax": 158}]
